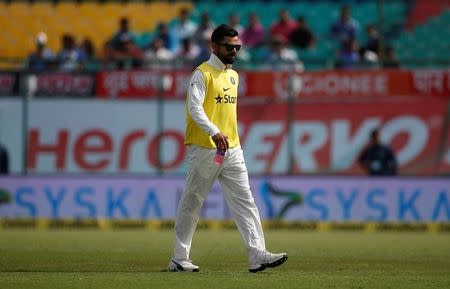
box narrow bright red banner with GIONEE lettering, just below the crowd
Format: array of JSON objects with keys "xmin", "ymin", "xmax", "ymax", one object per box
[{"xmin": 96, "ymin": 70, "xmax": 450, "ymax": 100}]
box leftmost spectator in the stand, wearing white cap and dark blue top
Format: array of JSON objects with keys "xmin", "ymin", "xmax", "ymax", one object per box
[{"xmin": 26, "ymin": 32, "xmax": 55, "ymax": 71}]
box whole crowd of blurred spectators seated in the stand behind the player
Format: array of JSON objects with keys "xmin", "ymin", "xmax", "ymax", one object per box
[{"xmin": 26, "ymin": 5, "xmax": 399, "ymax": 71}]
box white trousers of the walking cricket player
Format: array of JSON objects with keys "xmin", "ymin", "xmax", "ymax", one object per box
[{"xmin": 173, "ymin": 145, "xmax": 265, "ymax": 260}]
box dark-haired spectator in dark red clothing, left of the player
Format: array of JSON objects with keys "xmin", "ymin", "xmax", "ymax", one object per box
[{"xmin": 105, "ymin": 18, "xmax": 144, "ymax": 69}]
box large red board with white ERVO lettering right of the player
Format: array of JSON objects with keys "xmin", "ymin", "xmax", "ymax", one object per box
[{"xmin": 239, "ymin": 100, "xmax": 450, "ymax": 175}]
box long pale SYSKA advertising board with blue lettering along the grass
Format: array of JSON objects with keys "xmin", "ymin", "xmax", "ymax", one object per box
[{"xmin": 0, "ymin": 177, "xmax": 450, "ymax": 222}]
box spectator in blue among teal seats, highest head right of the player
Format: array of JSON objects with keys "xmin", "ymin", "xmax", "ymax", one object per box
[{"xmin": 330, "ymin": 5, "xmax": 359, "ymax": 45}]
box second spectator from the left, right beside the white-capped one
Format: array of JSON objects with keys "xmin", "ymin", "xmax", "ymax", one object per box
[{"xmin": 57, "ymin": 33, "xmax": 83, "ymax": 71}]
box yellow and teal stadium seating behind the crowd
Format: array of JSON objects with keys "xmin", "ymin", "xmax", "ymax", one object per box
[{"xmin": 0, "ymin": 0, "xmax": 450, "ymax": 70}]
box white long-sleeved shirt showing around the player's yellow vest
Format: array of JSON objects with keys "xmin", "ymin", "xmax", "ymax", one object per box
[{"xmin": 187, "ymin": 53, "xmax": 230, "ymax": 136}]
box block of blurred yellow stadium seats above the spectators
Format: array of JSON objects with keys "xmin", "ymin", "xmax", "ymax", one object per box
[{"xmin": 0, "ymin": 0, "xmax": 192, "ymax": 57}]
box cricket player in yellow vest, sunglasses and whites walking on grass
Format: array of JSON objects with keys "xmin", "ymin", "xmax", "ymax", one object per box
[{"xmin": 168, "ymin": 24, "xmax": 288, "ymax": 272}]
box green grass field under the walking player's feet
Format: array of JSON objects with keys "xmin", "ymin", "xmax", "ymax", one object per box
[{"xmin": 0, "ymin": 230, "xmax": 450, "ymax": 289}]
